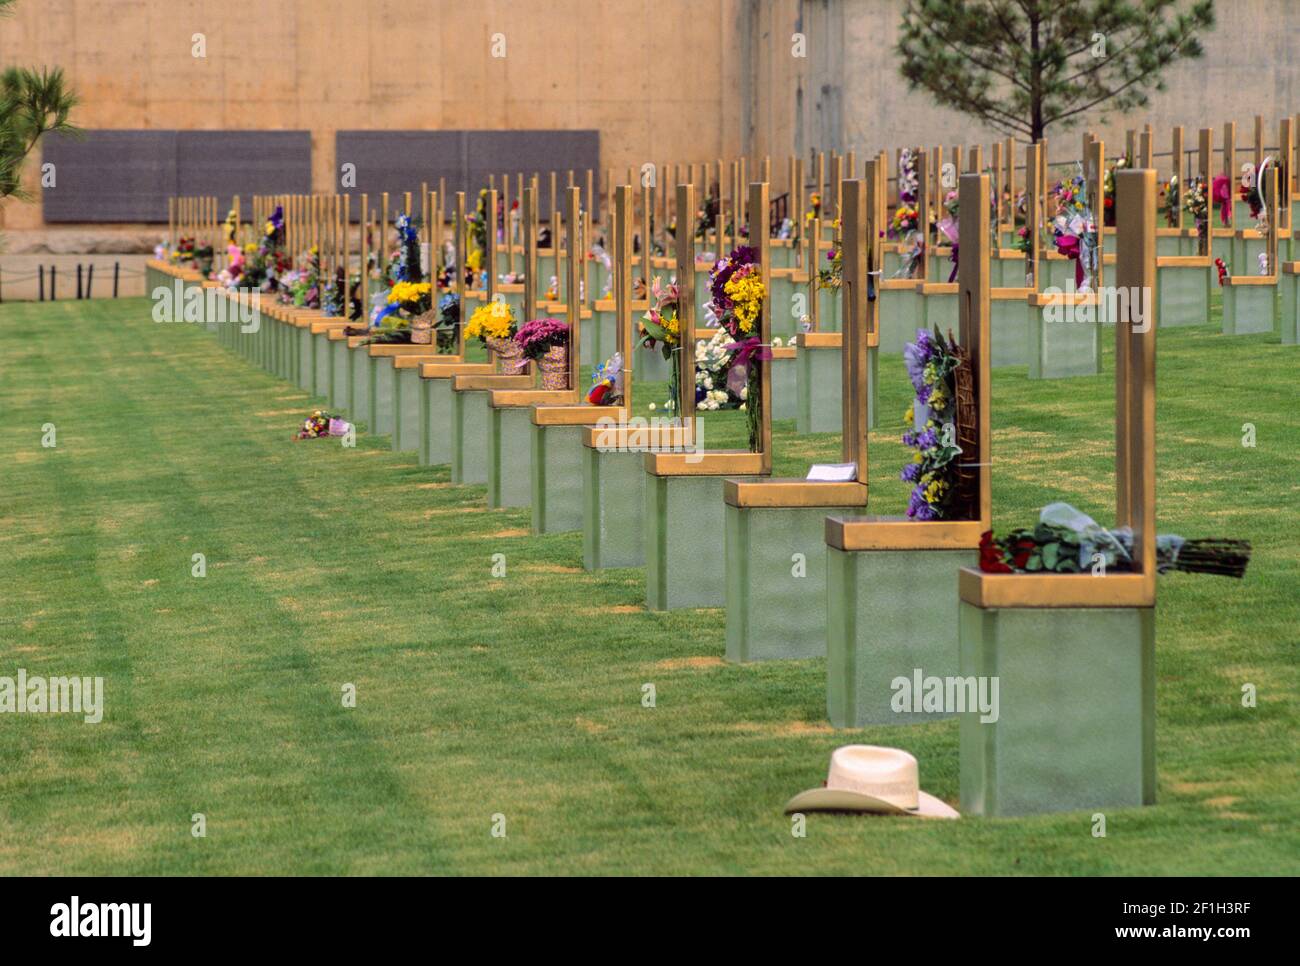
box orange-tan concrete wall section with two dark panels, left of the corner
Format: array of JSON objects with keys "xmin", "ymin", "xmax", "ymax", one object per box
[{"xmin": 0, "ymin": 0, "xmax": 744, "ymax": 230}]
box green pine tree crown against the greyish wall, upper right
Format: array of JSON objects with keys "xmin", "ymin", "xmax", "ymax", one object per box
[{"xmin": 894, "ymin": 0, "xmax": 1214, "ymax": 140}]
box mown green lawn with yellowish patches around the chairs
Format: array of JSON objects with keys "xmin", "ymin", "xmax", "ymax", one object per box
[{"xmin": 0, "ymin": 300, "xmax": 1300, "ymax": 875}]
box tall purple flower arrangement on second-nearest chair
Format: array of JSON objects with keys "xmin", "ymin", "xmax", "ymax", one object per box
[{"xmin": 898, "ymin": 329, "xmax": 962, "ymax": 520}]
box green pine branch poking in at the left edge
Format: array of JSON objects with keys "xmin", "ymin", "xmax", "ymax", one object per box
[{"xmin": 0, "ymin": 0, "xmax": 77, "ymax": 199}]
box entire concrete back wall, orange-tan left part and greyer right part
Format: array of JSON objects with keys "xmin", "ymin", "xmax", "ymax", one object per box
[{"xmin": 0, "ymin": 0, "xmax": 1300, "ymax": 240}]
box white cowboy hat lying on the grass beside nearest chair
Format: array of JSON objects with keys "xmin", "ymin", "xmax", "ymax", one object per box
[{"xmin": 785, "ymin": 745, "xmax": 961, "ymax": 818}]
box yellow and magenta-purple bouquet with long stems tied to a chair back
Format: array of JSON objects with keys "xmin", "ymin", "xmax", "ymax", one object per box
[{"xmin": 709, "ymin": 244, "xmax": 772, "ymax": 452}]
